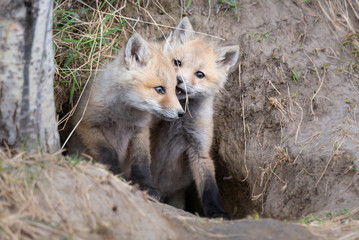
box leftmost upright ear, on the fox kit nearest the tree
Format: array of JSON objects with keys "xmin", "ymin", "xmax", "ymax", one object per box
[{"xmin": 125, "ymin": 33, "xmax": 151, "ymax": 65}]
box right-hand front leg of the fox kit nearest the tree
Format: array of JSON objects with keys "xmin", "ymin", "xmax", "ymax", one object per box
[{"xmin": 129, "ymin": 128, "xmax": 160, "ymax": 200}]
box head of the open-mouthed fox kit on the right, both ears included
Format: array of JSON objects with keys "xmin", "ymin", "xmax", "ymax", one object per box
[{"xmin": 165, "ymin": 18, "xmax": 239, "ymax": 100}]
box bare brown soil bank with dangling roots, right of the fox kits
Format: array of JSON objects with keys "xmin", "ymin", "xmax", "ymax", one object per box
[{"xmin": 210, "ymin": 1, "xmax": 359, "ymax": 219}]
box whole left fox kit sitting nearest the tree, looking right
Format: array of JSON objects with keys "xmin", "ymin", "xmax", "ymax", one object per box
[{"xmin": 68, "ymin": 34, "xmax": 184, "ymax": 198}]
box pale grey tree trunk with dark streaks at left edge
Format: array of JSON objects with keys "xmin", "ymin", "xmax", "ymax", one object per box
[{"xmin": 0, "ymin": 0, "xmax": 59, "ymax": 152}]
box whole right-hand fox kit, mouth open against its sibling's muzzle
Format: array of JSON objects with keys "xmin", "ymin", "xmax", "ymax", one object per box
[{"xmin": 150, "ymin": 18, "xmax": 239, "ymax": 219}]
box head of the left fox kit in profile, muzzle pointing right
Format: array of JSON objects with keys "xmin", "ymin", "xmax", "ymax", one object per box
[{"xmin": 122, "ymin": 34, "xmax": 184, "ymax": 120}]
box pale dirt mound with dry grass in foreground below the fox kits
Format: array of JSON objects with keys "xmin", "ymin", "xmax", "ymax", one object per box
[{"xmin": 0, "ymin": 150, "xmax": 316, "ymax": 239}]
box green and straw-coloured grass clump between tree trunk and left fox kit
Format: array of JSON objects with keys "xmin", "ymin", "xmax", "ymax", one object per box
[{"xmin": 53, "ymin": 0, "xmax": 125, "ymax": 112}]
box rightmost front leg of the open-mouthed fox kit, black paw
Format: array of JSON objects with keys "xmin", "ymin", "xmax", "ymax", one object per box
[{"xmin": 188, "ymin": 148, "xmax": 232, "ymax": 219}]
